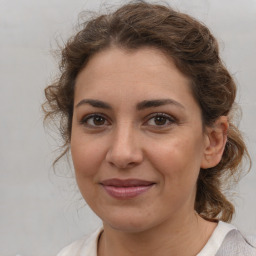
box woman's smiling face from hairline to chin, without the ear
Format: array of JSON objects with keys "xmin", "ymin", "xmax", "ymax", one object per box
[{"xmin": 71, "ymin": 48, "xmax": 209, "ymax": 232}]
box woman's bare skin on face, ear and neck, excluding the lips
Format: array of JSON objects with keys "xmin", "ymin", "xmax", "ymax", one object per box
[{"xmin": 71, "ymin": 47, "xmax": 228, "ymax": 256}]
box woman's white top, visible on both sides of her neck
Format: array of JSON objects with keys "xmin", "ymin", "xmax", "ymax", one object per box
[{"xmin": 57, "ymin": 221, "xmax": 256, "ymax": 256}]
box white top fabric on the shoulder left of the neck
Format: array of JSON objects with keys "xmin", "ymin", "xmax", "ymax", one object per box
[{"xmin": 57, "ymin": 228, "xmax": 102, "ymax": 256}]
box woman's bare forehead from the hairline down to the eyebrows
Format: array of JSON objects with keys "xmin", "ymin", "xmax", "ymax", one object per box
[{"xmin": 75, "ymin": 48, "xmax": 198, "ymax": 111}]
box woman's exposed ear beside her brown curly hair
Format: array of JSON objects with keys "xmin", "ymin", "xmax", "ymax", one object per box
[{"xmin": 200, "ymin": 116, "xmax": 228, "ymax": 169}]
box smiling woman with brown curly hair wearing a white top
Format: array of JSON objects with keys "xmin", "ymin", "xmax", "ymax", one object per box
[{"xmin": 44, "ymin": 2, "xmax": 256, "ymax": 256}]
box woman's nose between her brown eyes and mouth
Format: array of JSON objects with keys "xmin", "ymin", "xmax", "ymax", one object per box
[{"xmin": 106, "ymin": 125, "xmax": 143, "ymax": 169}]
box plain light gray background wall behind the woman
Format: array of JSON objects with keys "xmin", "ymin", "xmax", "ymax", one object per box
[{"xmin": 0, "ymin": 0, "xmax": 256, "ymax": 256}]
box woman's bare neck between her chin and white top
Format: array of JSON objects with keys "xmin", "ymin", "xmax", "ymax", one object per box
[{"xmin": 98, "ymin": 212, "xmax": 216, "ymax": 256}]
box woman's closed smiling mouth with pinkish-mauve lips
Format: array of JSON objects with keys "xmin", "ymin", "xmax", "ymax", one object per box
[{"xmin": 100, "ymin": 179, "xmax": 155, "ymax": 200}]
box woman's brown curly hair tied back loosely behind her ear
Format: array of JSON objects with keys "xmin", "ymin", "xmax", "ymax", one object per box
[{"xmin": 43, "ymin": 1, "xmax": 250, "ymax": 221}]
